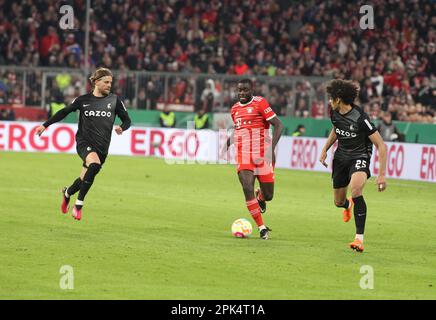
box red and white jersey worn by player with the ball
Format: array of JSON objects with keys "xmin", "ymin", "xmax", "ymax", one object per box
[{"xmin": 230, "ymin": 96, "xmax": 276, "ymax": 162}]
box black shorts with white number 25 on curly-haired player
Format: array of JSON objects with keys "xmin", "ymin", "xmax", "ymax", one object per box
[{"xmin": 332, "ymin": 158, "xmax": 371, "ymax": 189}]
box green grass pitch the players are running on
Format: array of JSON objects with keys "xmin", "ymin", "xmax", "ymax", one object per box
[{"xmin": 0, "ymin": 152, "xmax": 436, "ymax": 300}]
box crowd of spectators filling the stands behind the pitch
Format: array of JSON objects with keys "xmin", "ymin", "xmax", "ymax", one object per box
[{"xmin": 0, "ymin": 0, "xmax": 436, "ymax": 123}]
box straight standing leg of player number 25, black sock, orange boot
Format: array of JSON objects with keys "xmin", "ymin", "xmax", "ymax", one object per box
[{"xmin": 350, "ymin": 171, "xmax": 368, "ymax": 251}]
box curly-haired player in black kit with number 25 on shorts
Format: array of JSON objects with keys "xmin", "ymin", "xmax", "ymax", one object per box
[{"xmin": 319, "ymin": 80, "xmax": 386, "ymax": 252}]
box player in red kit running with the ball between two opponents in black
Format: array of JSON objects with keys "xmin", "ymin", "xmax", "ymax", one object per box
[{"xmin": 223, "ymin": 79, "xmax": 283, "ymax": 240}]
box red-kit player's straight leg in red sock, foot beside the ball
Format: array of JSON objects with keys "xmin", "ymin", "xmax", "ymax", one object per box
[{"xmin": 238, "ymin": 170, "xmax": 268, "ymax": 240}]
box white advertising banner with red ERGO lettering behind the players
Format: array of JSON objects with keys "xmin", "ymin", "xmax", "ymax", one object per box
[{"xmin": 0, "ymin": 121, "xmax": 436, "ymax": 182}]
